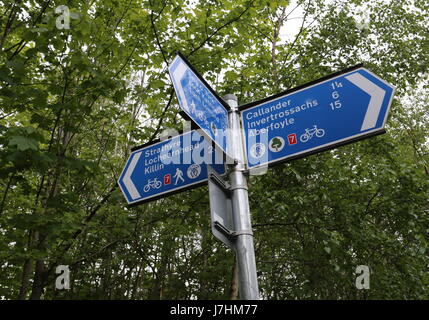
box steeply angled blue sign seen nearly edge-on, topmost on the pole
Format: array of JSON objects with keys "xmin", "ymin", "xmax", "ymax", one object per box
[{"xmin": 169, "ymin": 54, "xmax": 229, "ymax": 160}]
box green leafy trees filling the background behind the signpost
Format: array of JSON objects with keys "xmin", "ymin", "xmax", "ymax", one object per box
[{"xmin": 0, "ymin": 0, "xmax": 429, "ymax": 299}]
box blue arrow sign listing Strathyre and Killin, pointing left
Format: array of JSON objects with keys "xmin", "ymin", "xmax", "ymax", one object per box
[{"xmin": 118, "ymin": 130, "xmax": 225, "ymax": 204}]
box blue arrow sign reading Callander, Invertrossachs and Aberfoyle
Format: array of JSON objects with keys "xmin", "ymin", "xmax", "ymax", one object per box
[{"xmin": 240, "ymin": 66, "xmax": 394, "ymax": 168}]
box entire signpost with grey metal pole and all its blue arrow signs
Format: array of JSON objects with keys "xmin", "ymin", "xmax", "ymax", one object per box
[{"xmin": 118, "ymin": 54, "xmax": 394, "ymax": 300}]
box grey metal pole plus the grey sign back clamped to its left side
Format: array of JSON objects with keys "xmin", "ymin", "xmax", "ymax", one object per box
[{"xmin": 209, "ymin": 94, "xmax": 259, "ymax": 300}]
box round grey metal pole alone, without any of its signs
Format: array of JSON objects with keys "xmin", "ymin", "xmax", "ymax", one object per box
[{"xmin": 223, "ymin": 94, "xmax": 260, "ymax": 300}]
